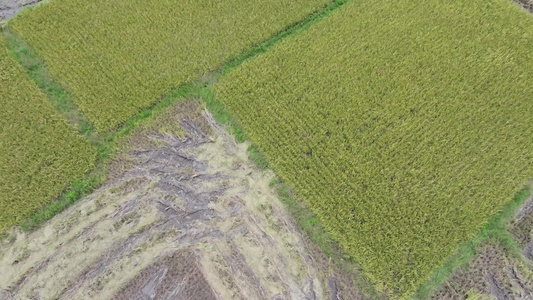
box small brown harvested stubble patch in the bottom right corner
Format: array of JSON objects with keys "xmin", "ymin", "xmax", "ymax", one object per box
[{"xmin": 431, "ymin": 196, "xmax": 533, "ymax": 300}]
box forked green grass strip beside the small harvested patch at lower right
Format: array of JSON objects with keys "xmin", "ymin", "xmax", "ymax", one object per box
[{"xmin": 414, "ymin": 185, "xmax": 532, "ymax": 299}]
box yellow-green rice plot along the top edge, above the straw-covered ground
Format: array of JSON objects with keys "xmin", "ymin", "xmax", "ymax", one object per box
[{"xmin": 8, "ymin": 0, "xmax": 331, "ymax": 132}]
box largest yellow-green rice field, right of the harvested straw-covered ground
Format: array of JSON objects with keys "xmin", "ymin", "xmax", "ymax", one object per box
[{"xmin": 215, "ymin": 0, "xmax": 533, "ymax": 297}]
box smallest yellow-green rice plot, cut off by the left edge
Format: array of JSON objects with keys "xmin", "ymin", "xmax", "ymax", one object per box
[{"xmin": 0, "ymin": 36, "xmax": 96, "ymax": 232}]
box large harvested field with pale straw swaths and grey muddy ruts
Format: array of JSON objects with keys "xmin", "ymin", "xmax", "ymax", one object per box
[{"xmin": 0, "ymin": 101, "xmax": 360, "ymax": 299}]
